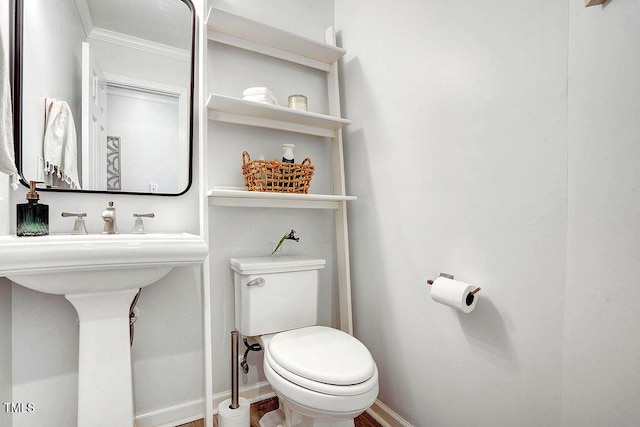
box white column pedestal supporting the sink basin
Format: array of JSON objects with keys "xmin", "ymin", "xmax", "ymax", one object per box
[{"xmin": 65, "ymin": 289, "xmax": 138, "ymax": 427}]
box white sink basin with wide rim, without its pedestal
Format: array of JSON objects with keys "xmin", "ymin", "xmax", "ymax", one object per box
[{"xmin": 0, "ymin": 233, "xmax": 207, "ymax": 295}]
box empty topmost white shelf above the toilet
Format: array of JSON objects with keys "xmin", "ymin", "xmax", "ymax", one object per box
[{"xmin": 207, "ymin": 7, "xmax": 346, "ymax": 72}]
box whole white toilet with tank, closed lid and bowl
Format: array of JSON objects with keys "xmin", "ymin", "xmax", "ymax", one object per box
[{"xmin": 230, "ymin": 256, "xmax": 378, "ymax": 427}]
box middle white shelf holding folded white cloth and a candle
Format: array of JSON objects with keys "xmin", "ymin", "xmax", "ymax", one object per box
[{"xmin": 207, "ymin": 94, "xmax": 351, "ymax": 138}]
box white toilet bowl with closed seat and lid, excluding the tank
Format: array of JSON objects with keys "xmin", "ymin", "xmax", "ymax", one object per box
[{"xmin": 259, "ymin": 326, "xmax": 378, "ymax": 427}]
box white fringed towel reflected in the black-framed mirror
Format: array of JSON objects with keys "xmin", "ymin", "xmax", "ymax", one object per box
[{"xmin": 43, "ymin": 98, "xmax": 80, "ymax": 189}]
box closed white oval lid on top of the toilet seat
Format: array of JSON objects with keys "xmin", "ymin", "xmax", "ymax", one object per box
[{"xmin": 269, "ymin": 326, "xmax": 376, "ymax": 386}]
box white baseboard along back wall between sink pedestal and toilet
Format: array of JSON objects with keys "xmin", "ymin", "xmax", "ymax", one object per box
[{"xmin": 135, "ymin": 381, "xmax": 275, "ymax": 427}]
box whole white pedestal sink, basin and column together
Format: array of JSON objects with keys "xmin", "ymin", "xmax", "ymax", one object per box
[{"xmin": 0, "ymin": 233, "xmax": 208, "ymax": 427}]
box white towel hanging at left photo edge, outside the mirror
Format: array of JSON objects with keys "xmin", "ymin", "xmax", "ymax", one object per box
[{"xmin": 0, "ymin": 24, "xmax": 19, "ymax": 190}]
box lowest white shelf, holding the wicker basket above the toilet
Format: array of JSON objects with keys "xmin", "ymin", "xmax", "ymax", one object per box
[{"xmin": 207, "ymin": 186, "xmax": 357, "ymax": 209}]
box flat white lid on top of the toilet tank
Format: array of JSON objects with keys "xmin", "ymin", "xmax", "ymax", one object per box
[{"xmin": 229, "ymin": 256, "xmax": 326, "ymax": 275}]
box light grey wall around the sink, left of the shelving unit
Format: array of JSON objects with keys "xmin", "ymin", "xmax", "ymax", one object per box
[{"xmin": 0, "ymin": 1, "xmax": 203, "ymax": 427}]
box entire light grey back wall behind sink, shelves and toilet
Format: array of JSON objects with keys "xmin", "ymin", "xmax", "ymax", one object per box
[{"xmin": 2, "ymin": 0, "xmax": 337, "ymax": 427}]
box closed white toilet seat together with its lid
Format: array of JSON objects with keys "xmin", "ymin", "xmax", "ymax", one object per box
[{"xmin": 265, "ymin": 326, "xmax": 378, "ymax": 396}]
